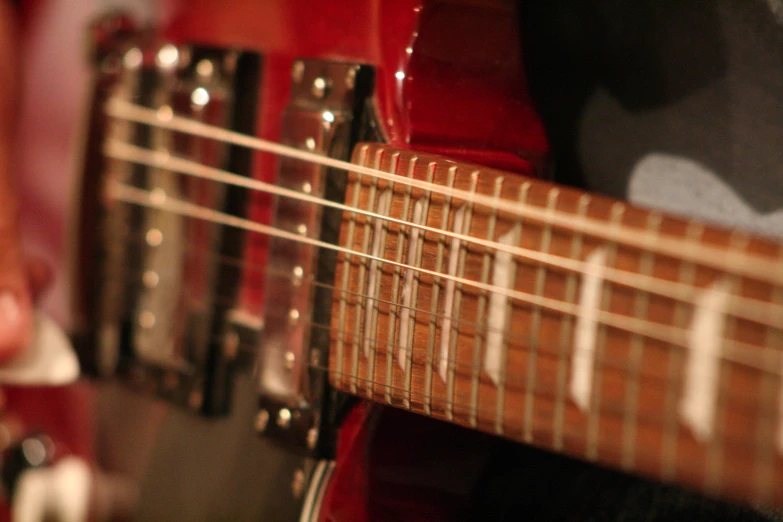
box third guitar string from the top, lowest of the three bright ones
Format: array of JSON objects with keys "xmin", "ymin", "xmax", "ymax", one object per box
[{"xmin": 108, "ymin": 181, "xmax": 780, "ymax": 370}]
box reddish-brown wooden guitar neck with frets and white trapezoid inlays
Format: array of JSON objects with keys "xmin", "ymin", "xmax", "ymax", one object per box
[{"xmin": 329, "ymin": 141, "xmax": 783, "ymax": 502}]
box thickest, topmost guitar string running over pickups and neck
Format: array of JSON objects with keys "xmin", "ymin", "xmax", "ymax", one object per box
[{"xmin": 105, "ymin": 97, "xmax": 783, "ymax": 285}]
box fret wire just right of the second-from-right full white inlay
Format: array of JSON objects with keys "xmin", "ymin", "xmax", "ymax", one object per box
[{"xmin": 582, "ymin": 203, "xmax": 625, "ymax": 460}]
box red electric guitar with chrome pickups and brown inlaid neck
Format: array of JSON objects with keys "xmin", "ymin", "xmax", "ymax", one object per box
[{"xmin": 6, "ymin": 0, "xmax": 783, "ymax": 522}]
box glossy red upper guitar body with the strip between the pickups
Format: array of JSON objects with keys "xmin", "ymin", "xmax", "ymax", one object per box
[{"xmin": 165, "ymin": 0, "xmax": 548, "ymax": 315}]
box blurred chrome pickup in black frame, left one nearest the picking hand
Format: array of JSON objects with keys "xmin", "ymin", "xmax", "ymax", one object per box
[{"xmin": 74, "ymin": 22, "xmax": 261, "ymax": 414}]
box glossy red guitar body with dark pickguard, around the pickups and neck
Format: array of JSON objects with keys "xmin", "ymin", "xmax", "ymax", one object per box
[{"xmin": 9, "ymin": 0, "xmax": 547, "ymax": 522}]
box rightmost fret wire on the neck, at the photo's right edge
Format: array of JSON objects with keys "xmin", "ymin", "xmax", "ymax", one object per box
[{"xmin": 754, "ymin": 278, "xmax": 783, "ymax": 505}]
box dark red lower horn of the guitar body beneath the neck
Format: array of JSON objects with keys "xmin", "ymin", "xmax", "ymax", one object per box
[{"xmin": 318, "ymin": 405, "xmax": 497, "ymax": 522}]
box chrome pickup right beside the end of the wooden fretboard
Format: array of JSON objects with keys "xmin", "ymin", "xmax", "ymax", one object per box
[{"xmin": 258, "ymin": 60, "xmax": 372, "ymax": 455}]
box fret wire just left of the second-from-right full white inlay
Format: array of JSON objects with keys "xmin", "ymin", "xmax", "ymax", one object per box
[{"xmin": 552, "ymin": 194, "xmax": 590, "ymax": 450}]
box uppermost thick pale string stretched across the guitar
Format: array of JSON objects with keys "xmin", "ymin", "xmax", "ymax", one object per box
[{"xmin": 105, "ymin": 98, "xmax": 783, "ymax": 284}]
